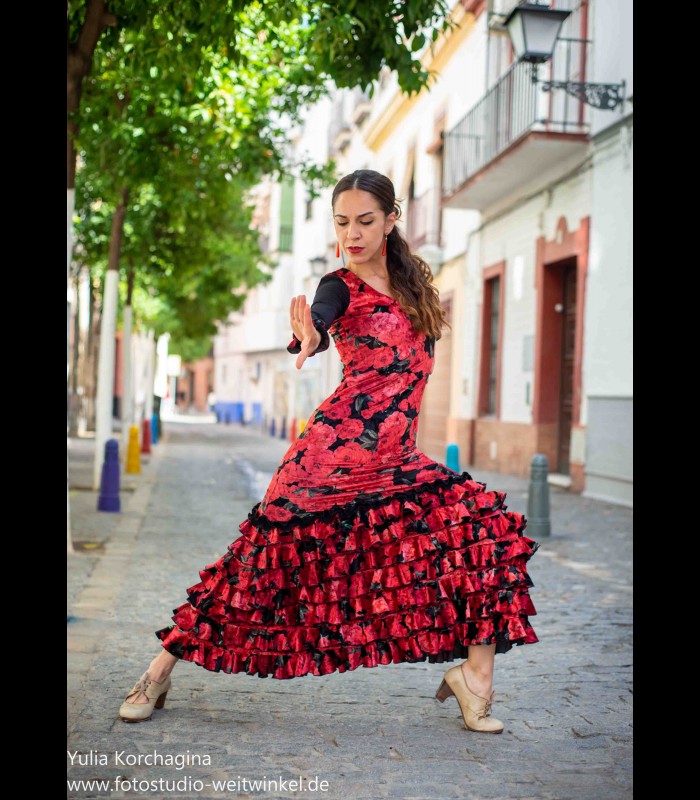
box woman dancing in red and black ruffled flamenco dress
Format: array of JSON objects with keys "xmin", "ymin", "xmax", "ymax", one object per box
[{"xmin": 120, "ymin": 170, "xmax": 537, "ymax": 733}]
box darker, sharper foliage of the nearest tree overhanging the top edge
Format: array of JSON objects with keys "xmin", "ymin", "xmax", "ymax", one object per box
[{"xmin": 67, "ymin": 0, "xmax": 449, "ymax": 195}]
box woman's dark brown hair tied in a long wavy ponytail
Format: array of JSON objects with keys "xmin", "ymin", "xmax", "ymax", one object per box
[{"xmin": 332, "ymin": 169, "xmax": 449, "ymax": 339}]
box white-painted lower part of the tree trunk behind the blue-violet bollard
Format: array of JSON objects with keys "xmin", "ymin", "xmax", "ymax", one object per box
[{"xmin": 92, "ymin": 269, "xmax": 119, "ymax": 491}]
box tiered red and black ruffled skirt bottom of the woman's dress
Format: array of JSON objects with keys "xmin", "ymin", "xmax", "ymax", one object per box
[{"xmin": 156, "ymin": 473, "xmax": 538, "ymax": 679}]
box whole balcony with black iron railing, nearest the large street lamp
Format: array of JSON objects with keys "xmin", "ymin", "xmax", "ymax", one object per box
[{"xmin": 442, "ymin": 47, "xmax": 589, "ymax": 209}]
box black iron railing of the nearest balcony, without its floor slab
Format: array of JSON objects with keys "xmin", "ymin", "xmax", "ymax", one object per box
[{"xmin": 443, "ymin": 39, "xmax": 588, "ymax": 198}]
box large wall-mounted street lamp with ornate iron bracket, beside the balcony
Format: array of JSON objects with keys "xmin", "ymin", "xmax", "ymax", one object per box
[{"xmin": 504, "ymin": 2, "xmax": 625, "ymax": 111}]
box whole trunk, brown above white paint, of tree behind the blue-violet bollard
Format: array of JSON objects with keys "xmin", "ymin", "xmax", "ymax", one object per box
[{"xmin": 93, "ymin": 189, "xmax": 129, "ymax": 491}]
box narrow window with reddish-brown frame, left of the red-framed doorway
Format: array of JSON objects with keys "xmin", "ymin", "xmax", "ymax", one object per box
[{"xmin": 479, "ymin": 262, "xmax": 505, "ymax": 419}]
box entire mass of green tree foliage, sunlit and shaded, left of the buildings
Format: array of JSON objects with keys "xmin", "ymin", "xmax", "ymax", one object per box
[{"xmin": 68, "ymin": 0, "xmax": 448, "ymax": 352}]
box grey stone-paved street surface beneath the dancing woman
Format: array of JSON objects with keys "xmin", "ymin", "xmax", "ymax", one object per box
[{"xmin": 67, "ymin": 417, "xmax": 632, "ymax": 800}]
